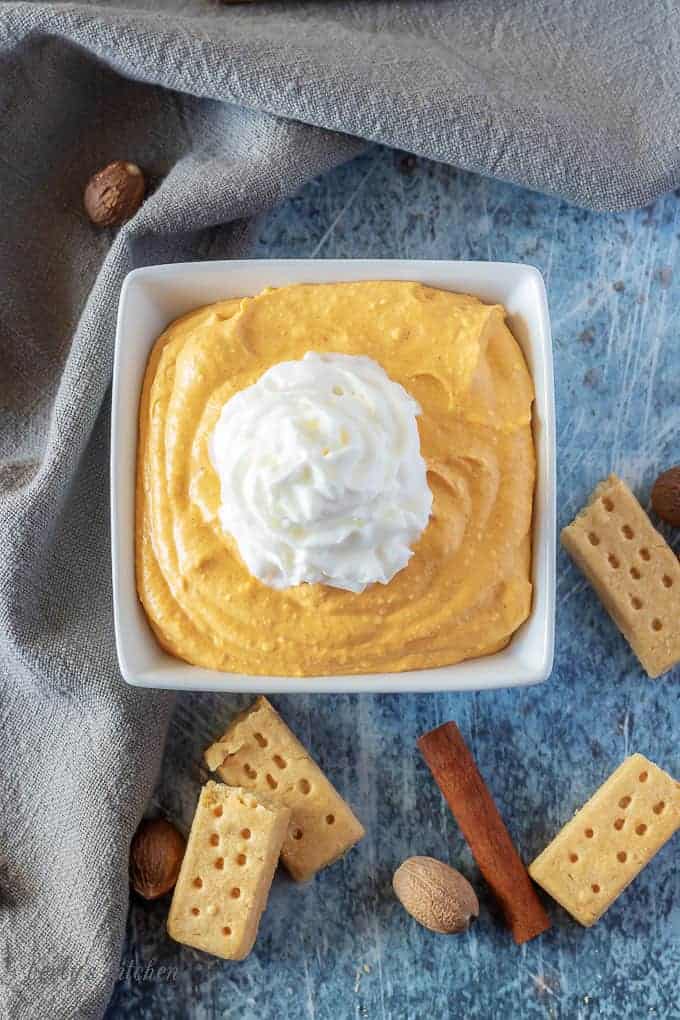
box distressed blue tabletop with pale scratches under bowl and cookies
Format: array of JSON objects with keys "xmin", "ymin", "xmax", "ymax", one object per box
[{"xmin": 108, "ymin": 149, "xmax": 680, "ymax": 1020}]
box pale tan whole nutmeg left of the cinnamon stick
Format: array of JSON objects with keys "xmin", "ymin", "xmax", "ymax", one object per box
[{"xmin": 391, "ymin": 857, "xmax": 479, "ymax": 935}]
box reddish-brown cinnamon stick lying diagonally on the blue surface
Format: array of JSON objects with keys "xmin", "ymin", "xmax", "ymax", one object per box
[{"xmin": 418, "ymin": 722, "xmax": 551, "ymax": 945}]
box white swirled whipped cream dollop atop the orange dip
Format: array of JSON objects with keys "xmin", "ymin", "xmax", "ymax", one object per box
[{"xmin": 210, "ymin": 352, "xmax": 432, "ymax": 592}]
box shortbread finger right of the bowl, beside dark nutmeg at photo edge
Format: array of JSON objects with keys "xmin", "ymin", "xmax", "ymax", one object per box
[{"xmin": 562, "ymin": 474, "xmax": 680, "ymax": 676}]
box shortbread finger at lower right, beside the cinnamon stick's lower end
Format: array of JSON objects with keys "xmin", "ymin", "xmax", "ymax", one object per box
[{"xmin": 529, "ymin": 755, "xmax": 680, "ymax": 927}]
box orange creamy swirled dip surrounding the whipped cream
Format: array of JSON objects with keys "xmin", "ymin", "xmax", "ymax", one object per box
[{"xmin": 137, "ymin": 282, "xmax": 535, "ymax": 676}]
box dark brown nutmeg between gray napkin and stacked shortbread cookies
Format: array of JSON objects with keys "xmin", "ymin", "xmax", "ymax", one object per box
[{"xmin": 129, "ymin": 818, "xmax": 187, "ymax": 900}]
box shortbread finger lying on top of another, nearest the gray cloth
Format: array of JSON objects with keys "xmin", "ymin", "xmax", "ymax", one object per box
[{"xmin": 167, "ymin": 782, "xmax": 291, "ymax": 960}]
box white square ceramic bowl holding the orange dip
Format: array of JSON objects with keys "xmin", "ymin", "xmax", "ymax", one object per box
[{"xmin": 111, "ymin": 259, "xmax": 556, "ymax": 694}]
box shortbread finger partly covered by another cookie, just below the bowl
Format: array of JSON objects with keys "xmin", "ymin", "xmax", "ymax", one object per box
[{"xmin": 205, "ymin": 698, "xmax": 364, "ymax": 881}]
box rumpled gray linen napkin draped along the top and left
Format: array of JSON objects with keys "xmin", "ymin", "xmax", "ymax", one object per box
[{"xmin": 0, "ymin": 0, "xmax": 680, "ymax": 1020}]
